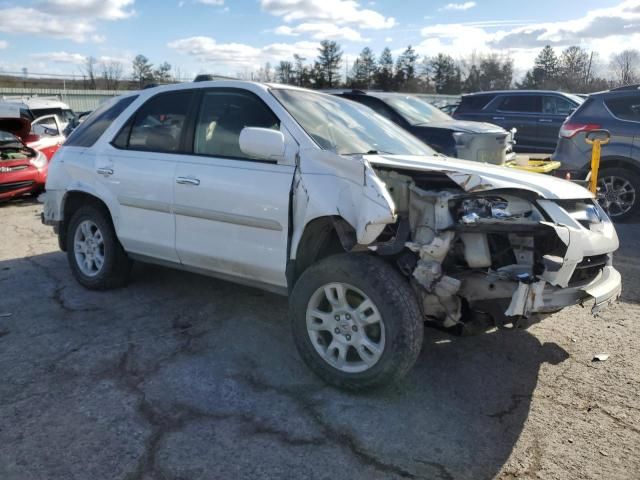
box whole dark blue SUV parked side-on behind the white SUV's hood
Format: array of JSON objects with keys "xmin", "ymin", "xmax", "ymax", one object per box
[{"xmin": 453, "ymin": 90, "xmax": 584, "ymax": 153}]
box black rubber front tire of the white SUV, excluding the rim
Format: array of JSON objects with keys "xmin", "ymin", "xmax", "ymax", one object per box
[{"xmin": 289, "ymin": 254, "xmax": 424, "ymax": 390}]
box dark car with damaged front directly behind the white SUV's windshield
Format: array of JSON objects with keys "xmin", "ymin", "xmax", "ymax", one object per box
[{"xmin": 330, "ymin": 90, "xmax": 515, "ymax": 165}]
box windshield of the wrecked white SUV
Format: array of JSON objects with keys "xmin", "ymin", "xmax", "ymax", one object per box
[{"xmin": 271, "ymin": 88, "xmax": 435, "ymax": 155}]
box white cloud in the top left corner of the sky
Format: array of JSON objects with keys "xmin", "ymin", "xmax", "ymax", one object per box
[{"xmin": 0, "ymin": 0, "xmax": 135, "ymax": 43}]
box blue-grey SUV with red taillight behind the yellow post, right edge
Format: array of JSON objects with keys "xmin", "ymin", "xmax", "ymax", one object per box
[{"xmin": 552, "ymin": 85, "xmax": 640, "ymax": 220}]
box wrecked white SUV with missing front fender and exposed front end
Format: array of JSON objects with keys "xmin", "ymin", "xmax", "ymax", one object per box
[{"xmin": 43, "ymin": 81, "xmax": 621, "ymax": 389}]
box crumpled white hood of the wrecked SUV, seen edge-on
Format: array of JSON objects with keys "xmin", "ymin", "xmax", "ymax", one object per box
[{"xmin": 364, "ymin": 155, "xmax": 593, "ymax": 200}]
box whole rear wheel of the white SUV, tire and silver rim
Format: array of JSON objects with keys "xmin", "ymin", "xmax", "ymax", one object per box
[{"xmin": 66, "ymin": 205, "xmax": 132, "ymax": 290}]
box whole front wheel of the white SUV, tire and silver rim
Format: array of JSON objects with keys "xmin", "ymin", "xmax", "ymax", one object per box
[{"xmin": 289, "ymin": 254, "xmax": 424, "ymax": 390}]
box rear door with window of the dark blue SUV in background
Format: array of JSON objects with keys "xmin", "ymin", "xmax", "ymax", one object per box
[{"xmin": 491, "ymin": 95, "xmax": 542, "ymax": 152}]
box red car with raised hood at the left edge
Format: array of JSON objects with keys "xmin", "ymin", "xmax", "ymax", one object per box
[{"xmin": 0, "ymin": 117, "xmax": 49, "ymax": 201}]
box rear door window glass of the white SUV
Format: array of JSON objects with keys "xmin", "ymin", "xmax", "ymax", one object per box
[{"xmin": 123, "ymin": 91, "xmax": 194, "ymax": 153}]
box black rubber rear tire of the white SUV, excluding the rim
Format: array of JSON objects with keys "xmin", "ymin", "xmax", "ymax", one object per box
[{"xmin": 66, "ymin": 205, "xmax": 132, "ymax": 290}]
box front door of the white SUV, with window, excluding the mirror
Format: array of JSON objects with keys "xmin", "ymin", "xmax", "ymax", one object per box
[{"xmin": 174, "ymin": 88, "xmax": 295, "ymax": 287}]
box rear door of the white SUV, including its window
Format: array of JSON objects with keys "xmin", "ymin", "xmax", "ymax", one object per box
[{"xmin": 96, "ymin": 90, "xmax": 194, "ymax": 263}]
